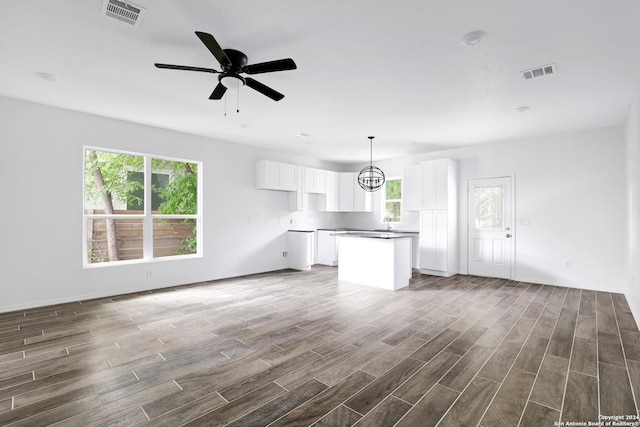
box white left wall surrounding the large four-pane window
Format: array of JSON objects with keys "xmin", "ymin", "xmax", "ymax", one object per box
[{"xmin": 0, "ymin": 97, "xmax": 341, "ymax": 312}]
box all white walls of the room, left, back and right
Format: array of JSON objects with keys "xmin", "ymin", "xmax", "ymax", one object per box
[{"xmin": 0, "ymin": 97, "xmax": 640, "ymax": 315}]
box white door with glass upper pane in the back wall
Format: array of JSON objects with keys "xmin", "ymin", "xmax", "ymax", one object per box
[{"xmin": 467, "ymin": 177, "xmax": 513, "ymax": 279}]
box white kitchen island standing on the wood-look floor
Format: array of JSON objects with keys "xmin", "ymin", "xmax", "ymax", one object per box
[{"xmin": 332, "ymin": 231, "xmax": 412, "ymax": 290}]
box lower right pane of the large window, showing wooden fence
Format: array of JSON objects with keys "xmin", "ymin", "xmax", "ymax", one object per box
[{"xmin": 153, "ymin": 219, "xmax": 198, "ymax": 258}]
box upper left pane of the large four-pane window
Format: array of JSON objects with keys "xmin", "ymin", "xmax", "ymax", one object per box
[{"xmin": 84, "ymin": 150, "xmax": 144, "ymax": 214}]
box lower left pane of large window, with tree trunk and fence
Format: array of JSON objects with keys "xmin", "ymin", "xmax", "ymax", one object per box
[{"xmin": 87, "ymin": 219, "xmax": 142, "ymax": 264}]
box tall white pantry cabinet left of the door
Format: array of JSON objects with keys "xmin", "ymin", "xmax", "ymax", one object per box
[{"xmin": 404, "ymin": 159, "xmax": 458, "ymax": 277}]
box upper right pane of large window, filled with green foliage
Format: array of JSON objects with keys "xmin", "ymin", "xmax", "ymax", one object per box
[{"xmin": 151, "ymin": 158, "xmax": 198, "ymax": 215}]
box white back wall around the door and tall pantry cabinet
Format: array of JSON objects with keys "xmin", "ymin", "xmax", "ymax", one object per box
[{"xmin": 346, "ymin": 127, "xmax": 628, "ymax": 292}]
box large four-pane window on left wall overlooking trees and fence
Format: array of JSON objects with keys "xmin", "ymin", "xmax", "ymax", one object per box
[{"xmin": 83, "ymin": 147, "xmax": 202, "ymax": 266}]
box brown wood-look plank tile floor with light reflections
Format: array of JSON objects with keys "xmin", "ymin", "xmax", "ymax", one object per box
[{"xmin": 0, "ymin": 266, "xmax": 640, "ymax": 427}]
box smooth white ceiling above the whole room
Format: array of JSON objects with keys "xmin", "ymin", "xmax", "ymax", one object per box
[{"xmin": 0, "ymin": 0, "xmax": 640, "ymax": 163}]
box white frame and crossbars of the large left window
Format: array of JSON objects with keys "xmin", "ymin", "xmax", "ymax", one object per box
[{"xmin": 82, "ymin": 145, "xmax": 204, "ymax": 268}]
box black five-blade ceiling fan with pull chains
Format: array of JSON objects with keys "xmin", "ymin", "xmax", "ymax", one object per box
[{"xmin": 155, "ymin": 31, "xmax": 297, "ymax": 101}]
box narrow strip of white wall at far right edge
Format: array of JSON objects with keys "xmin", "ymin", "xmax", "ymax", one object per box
[{"xmin": 625, "ymin": 92, "xmax": 640, "ymax": 321}]
